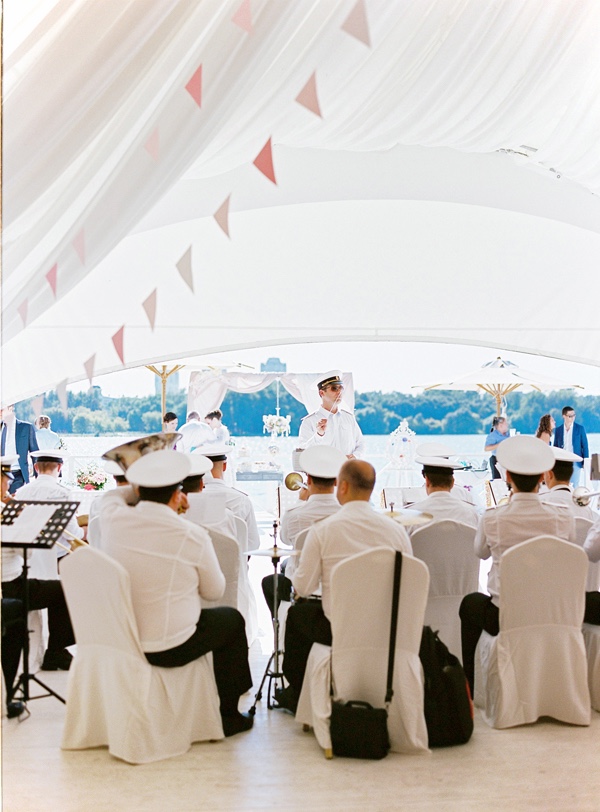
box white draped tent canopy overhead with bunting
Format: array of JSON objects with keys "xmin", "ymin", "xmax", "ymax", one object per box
[{"xmin": 2, "ymin": 0, "xmax": 600, "ymax": 403}]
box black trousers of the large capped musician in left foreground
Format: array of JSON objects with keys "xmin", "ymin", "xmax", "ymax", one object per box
[{"xmin": 146, "ymin": 606, "xmax": 252, "ymax": 716}]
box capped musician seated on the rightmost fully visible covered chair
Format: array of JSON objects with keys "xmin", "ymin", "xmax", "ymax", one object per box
[{"xmin": 459, "ymin": 436, "xmax": 576, "ymax": 693}]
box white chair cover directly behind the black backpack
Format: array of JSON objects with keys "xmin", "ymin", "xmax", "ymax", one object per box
[{"xmin": 411, "ymin": 519, "xmax": 480, "ymax": 661}]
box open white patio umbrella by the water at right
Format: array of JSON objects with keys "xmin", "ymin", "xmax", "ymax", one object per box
[{"xmin": 412, "ymin": 356, "xmax": 583, "ymax": 415}]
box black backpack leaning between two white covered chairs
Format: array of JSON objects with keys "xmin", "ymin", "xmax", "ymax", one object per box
[{"xmin": 419, "ymin": 626, "xmax": 473, "ymax": 747}]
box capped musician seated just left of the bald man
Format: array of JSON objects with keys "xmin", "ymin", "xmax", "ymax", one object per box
[{"xmin": 262, "ymin": 446, "xmax": 346, "ymax": 610}]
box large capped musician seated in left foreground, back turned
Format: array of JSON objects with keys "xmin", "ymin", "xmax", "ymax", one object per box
[{"xmin": 102, "ymin": 450, "xmax": 252, "ymax": 736}]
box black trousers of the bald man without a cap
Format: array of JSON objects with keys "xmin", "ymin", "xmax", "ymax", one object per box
[{"xmin": 283, "ymin": 599, "xmax": 331, "ymax": 694}]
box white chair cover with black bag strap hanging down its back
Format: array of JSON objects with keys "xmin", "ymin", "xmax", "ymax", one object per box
[{"xmin": 296, "ymin": 548, "xmax": 429, "ymax": 753}]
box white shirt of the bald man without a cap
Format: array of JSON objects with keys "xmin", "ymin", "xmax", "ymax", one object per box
[{"xmin": 292, "ymin": 501, "xmax": 412, "ymax": 617}]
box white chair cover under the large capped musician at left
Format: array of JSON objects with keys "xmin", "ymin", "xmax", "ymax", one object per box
[{"xmin": 61, "ymin": 548, "xmax": 223, "ymax": 764}]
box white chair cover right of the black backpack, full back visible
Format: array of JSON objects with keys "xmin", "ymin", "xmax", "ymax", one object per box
[{"xmin": 475, "ymin": 536, "xmax": 591, "ymax": 728}]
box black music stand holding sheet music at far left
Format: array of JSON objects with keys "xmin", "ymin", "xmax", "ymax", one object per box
[{"xmin": 0, "ymin": 499, "xmax": 79, "ymax": 704}]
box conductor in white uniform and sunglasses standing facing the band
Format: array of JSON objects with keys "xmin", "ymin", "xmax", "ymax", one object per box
[{"xmin": 298, "ymin": 370, "xmax": 364, "ymax": 460}]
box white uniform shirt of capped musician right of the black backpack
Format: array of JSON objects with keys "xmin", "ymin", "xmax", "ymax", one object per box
[{"xmin": 475, "ymin": 493, "xmax": 576, "ymax": 606}]
